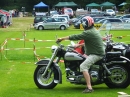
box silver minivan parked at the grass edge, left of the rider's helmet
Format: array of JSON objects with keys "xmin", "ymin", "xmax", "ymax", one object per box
[{"xmin": 34, "ymin": 17, "xmax": 69, "ymax": 30}]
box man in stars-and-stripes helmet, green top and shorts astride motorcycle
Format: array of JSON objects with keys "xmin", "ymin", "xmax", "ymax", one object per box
[{"xmin": 57, "ymin": 16, "xmax": 105, "ymax": 93}]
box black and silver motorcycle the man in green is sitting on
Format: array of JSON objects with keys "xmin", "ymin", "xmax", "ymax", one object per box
[{"xmin": 34, "ymin": 41, "xmax": 130, "ymax": 89}]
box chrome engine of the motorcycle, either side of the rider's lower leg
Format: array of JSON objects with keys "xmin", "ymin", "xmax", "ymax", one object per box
[{"xmin": 66, "ymin": 65, "xmax": 99, "ymax": 84}]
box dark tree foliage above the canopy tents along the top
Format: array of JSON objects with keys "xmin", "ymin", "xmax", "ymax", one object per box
[{"xmin": 0, "ymin": 0, "xmax": 130, "ymax": 11}]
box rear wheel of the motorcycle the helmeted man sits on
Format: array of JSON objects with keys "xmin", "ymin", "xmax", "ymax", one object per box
[{"xmin": 105, "ymin": 64, "xmax": 130, "ymax": 88}]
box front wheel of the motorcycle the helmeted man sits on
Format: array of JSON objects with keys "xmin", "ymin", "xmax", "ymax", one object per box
[{"xmin": 34, "ymin": 65, "xmax": 59, "ymax": 89}]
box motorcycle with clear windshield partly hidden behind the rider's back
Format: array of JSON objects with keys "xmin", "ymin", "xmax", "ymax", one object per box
[{"xmin": 98, "ymin": 21, "xmax": 130, "ymax": 59}]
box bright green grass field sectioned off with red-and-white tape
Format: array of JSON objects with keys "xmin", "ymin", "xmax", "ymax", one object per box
[{"xmin": 0, "ymin": 17, "xmax": 130, "ymax": 97}]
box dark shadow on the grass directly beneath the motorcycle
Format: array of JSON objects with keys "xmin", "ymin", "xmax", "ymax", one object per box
[{"xmin": 17, "ymin": 85, "xmax": 127, "ymax": 96}]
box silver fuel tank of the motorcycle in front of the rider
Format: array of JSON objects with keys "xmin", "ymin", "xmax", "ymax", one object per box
[{"xmin": 64, "ymin": 52, "xmax": 83, "ymax": 61}]
